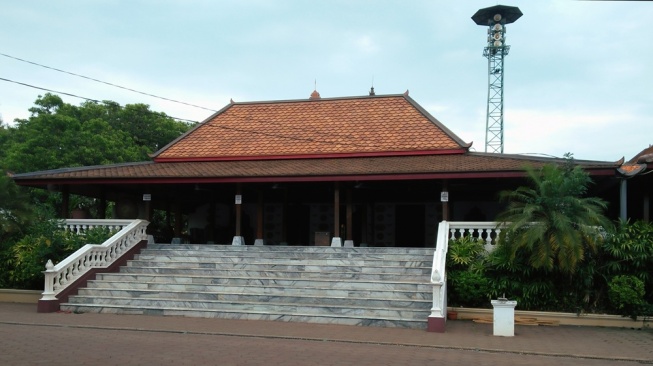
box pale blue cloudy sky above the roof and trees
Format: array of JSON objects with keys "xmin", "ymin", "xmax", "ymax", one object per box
[{"xmin": 0, "ymin": 0, "xmax": 653, "ymax": 161}]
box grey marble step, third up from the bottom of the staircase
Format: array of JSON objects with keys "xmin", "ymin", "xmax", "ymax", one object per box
[{"xmin": 91, "ymin": 273, "xmax": 432, "ymax": 291}]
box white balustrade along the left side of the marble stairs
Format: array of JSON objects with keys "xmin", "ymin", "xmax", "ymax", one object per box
[{"xmin": 41, "ymin": 220, "xmax": 149, "ymax": 300}]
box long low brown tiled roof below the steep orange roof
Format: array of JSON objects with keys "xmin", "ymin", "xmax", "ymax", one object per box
[{"xmin": 14, "ymin": 152, "xmax": 622, "ymax": 185}]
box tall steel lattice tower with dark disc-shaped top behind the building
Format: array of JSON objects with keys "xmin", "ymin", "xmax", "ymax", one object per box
[{"xmin": 472, "ymin": 5, "xmax": 522, "ymax": 154}]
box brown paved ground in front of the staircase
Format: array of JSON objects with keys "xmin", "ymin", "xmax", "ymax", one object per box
[{"xmin": 0, "ymin": 303, "xmax": 653, "ymax": 366}]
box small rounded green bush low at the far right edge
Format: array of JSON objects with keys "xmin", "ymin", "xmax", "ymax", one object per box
[{"xmin": 608, "ymin": 275, "xmax": 646, "ymax": 319}]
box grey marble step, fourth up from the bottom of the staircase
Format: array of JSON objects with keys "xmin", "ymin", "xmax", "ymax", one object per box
[{"xmin": 122, "ymin": 264, "xmax": 429, "ymax": 281}]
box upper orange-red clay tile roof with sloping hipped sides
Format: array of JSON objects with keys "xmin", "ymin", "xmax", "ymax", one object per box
[{"xmin": 153, "ymin": 95, "xmax": 469, "ymax": 162}]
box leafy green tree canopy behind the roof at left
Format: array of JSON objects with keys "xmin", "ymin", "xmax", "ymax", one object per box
[{"xmin": 0, "ymin": 93, "xmax": 190, "ymax": 173}]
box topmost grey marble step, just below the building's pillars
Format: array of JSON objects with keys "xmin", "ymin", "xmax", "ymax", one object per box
[{"xmin": 147, "ymin": 244, "xmax": 435, "ymax": 255}]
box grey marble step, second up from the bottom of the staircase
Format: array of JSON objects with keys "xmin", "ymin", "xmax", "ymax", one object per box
[{"xmin": 70, "ymin": 288, "xmax": 432, "ymax": 309}]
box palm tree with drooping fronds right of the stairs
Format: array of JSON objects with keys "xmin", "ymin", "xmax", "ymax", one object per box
[{"xmin": 499, "ymin": 154, "xmax": 612, "ymax": 273}]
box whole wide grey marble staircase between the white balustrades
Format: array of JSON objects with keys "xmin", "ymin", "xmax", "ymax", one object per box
[{"xmin": 61, "ymin": 244, "xmax": 433, "ymax": 328}]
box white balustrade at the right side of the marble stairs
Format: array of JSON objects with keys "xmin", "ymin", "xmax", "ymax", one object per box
[{"xmin": 429, "ymin": 221, "xmax": 501, "ymax": 319}]
